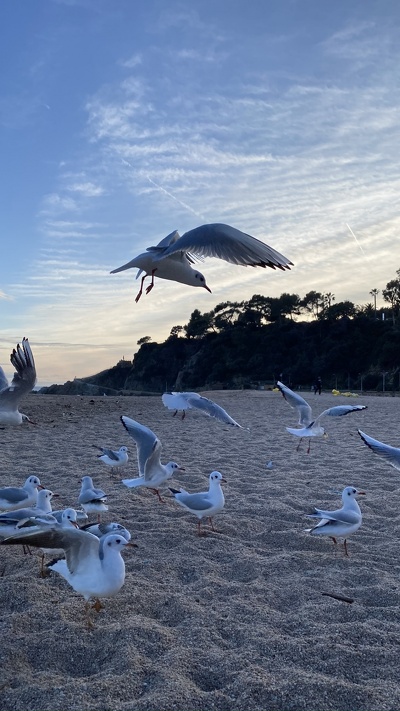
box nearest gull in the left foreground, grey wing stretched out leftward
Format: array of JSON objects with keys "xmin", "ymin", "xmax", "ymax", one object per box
[{"xmin": 2, "ymin": 524, "xmax": 137, "ymax": 627}]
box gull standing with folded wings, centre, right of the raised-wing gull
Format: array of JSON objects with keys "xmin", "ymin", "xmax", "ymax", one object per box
[{"xmin": 169, "ymin": 472, "xmax": 226, "ymax": 536}]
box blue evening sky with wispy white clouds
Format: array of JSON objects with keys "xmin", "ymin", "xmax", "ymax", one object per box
[{"xmin": 0, "ymin": 0, "xmax": 400, "ymax": 385}]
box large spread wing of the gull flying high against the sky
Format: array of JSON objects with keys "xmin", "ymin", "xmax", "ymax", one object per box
[{"xmin": 159, "ymin": 223, "xmax": 292, "ymax": 270}]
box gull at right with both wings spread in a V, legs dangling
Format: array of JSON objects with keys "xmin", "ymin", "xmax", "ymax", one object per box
[{"xmin": 276, "ymin": 380, "xmax": 367, "ymax": 453}]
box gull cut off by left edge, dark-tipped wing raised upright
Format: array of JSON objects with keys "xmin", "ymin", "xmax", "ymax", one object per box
[{"xmin": 0, "ymin": 338, "xmax": 36, "ymax": 425}]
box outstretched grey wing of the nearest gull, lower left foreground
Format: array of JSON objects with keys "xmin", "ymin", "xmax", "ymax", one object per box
[{"xmin": 1, "ymin": 526, "xmax": 99, "ymax": 573}]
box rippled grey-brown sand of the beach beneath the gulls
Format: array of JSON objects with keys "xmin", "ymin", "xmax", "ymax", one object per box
[{"xmin": 0, "ymin": 391, "xmax": 400, "ymax": 711}]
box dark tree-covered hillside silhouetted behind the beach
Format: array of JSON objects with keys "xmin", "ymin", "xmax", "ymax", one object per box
[{"xmin": 47, "ymin": 269, "xmax": 400, "ymax": 392}]
